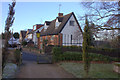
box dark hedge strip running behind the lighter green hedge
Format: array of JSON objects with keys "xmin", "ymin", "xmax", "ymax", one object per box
[{"xmin": 45, "ymin": 46, "xmax": 120, "ymax": 58}]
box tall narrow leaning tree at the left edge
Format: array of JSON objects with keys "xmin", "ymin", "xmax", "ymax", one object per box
[{"xmin": 2, "ymin": 0, "xmax": 16, "ymax": 70}]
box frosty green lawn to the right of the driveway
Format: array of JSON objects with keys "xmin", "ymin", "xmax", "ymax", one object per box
[{"xmin": 59, "ymin": 62, "xmax": 120, "ymax": 78}]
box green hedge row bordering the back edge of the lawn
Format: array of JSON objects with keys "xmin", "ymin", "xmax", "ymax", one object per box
[{"xmin": 52, "ymin": 47, "xmax": 120, "ymax": 62}]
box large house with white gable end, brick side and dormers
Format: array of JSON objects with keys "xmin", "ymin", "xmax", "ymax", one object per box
[{"xmin": 39, "ymin": 12, "xmax": 83, "ymax": 49}]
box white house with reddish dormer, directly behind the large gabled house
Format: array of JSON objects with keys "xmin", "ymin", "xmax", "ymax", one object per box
[{"xmin": 32, "ymin": 24, "xmax": 43, "ymax": 46}]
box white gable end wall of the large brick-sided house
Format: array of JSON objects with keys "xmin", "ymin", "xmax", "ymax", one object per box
[{"xmin": 61, "ymin": 15, "xmax": 83, "ymax": 46}]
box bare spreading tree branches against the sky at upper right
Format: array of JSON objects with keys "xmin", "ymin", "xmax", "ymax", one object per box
[{"xmin": 79, "ymin": 2, "xmax": 120, "ymax": 38}]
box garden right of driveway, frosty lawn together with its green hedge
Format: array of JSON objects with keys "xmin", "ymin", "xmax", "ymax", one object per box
[{"xmin": 52, "ymin": 46, "xmax": 120, "ymax": 78}]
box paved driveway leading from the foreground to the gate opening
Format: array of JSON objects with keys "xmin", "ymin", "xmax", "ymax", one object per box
[{"xmin": 16, "ymin": 51, "xmax": 74, "ymax": 78}]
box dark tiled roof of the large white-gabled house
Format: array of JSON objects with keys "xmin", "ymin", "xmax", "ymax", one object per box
[{"xmin": 41, "ymin": 12, "xmax": 82, "ymax": 36}]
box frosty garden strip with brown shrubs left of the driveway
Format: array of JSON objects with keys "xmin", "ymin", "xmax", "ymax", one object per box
[{"xmin": 2, "ymin": 48, "xmax": 22, "ymax": 78}]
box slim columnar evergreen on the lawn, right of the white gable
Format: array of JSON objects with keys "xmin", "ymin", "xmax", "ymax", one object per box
[{"xmin": 82, "ymin": 15, "xmax": 91, "ymax": 77}]
